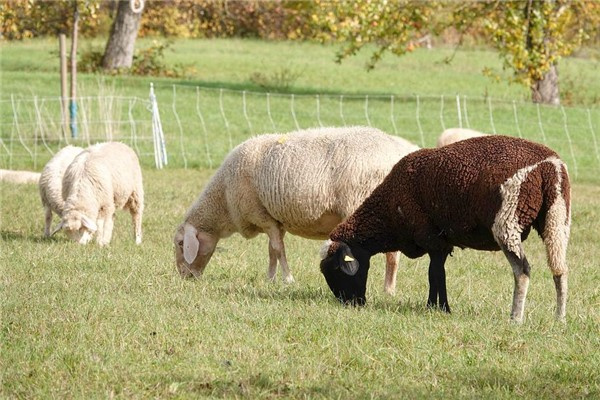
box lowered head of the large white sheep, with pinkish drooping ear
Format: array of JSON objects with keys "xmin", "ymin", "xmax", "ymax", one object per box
[{"xmin": 173, "ymin": 222, "xmax": 218, "ymax": 278}]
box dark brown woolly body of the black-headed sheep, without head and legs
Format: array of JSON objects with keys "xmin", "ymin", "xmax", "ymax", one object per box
[{"xmin": 331, "ymin": 135, "xmax": 570, "ymax": 257}]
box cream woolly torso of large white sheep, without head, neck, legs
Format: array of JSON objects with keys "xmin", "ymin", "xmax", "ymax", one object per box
[{"xmin": 218, "ymin": 127, "xmax": 418, "ymax": 239}]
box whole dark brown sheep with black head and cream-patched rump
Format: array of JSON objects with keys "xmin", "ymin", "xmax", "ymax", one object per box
[{"xmin": 321, "ymin": 135, "xmax": 571, "ymax": 322}]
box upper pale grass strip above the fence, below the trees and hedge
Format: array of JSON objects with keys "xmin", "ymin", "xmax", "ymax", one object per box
[{"xmin": 0, "ymin": 39, "xmax": 600, "ymax": 102}]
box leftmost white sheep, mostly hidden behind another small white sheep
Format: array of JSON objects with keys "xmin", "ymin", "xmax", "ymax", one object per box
[{"xmin": 39, "ymin": 146, "xmax": 83, "ymax": 236}]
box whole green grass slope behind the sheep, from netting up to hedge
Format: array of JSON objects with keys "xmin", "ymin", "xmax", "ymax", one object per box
[{"xmin": 0, "ymin": 40, "xmax": 600, "ymax": 183}]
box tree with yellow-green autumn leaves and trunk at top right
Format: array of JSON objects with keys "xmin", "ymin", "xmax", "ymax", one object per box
[{"xmin": 313, "ymin": 0, "xmax": 600, "ymax": 104}]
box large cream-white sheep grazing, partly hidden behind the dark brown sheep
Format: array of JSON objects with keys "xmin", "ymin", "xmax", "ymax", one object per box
[{"xmin": 174, "ymin": 127, "xmax": 418, "ymax": 293}]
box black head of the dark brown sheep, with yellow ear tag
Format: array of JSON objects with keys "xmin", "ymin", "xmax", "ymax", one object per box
[{"xmin": 321, "ymin": 242, "xmax": 370, "ymax": 306}]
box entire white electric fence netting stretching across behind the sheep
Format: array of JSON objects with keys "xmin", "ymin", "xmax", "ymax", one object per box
[{"xmin": 0, "ymin": 85, "xmax": 600, "ymax": 182}]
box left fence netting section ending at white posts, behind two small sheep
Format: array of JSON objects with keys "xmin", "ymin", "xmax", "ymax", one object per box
[{"xmin": 0, "ymin": 96, "xmax": 161, "ymax": 171}]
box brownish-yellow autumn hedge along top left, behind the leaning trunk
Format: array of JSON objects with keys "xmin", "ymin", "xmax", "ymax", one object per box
[{"xmin": 0, "ymin": 0, "xmax": 315, "ymax": 40}]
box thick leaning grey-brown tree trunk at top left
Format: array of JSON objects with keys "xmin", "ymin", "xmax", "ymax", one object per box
[{"xmin": 102, "ymin": 0, "xmax": 142, "ymax": 69}]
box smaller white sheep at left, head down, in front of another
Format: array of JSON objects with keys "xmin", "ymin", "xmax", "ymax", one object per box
[{"xmin": 55, "ymin": 142, "xmax": 144, "ymax": 246}]
